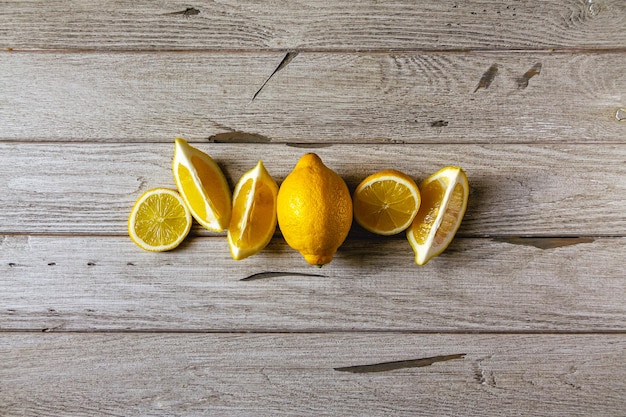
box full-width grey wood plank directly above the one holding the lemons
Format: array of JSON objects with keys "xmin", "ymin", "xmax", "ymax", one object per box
[{"xmin": 0, "ymin": 52, "xmax": 626, "ymax": 143}]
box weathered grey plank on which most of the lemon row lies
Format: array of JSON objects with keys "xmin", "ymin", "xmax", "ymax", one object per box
[{"xmin": 0, "ymin": 140, "xmax": 626, "ymax": 236}]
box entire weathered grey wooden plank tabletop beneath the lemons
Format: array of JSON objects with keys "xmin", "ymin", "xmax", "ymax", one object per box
[{"xmin": 0, "ymin": 0, "xmax": 626, "ymax": 416}]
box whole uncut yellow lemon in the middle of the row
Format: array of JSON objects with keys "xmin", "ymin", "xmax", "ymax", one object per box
[{"xmin": 277, "ymin": 153, "xmax": 352, "ymax": 266}]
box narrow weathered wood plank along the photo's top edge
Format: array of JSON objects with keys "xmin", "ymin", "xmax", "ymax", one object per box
[{"xmin": 0, "ymin": 0, "xmax": 626, "ymax": 50}]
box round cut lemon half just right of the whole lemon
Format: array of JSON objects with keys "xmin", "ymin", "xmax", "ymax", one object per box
[{"xmin": 353, "ymin": 169, "xmax": 421, "ymax": 236}]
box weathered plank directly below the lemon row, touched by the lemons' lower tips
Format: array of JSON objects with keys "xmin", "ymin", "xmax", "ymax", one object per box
[{"xmin": 0, "ymin": 236, "xmax": 626, "ymax": 332}]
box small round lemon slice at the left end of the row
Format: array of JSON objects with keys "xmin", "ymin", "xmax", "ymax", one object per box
[{"xmin": 128, "ymin": 188, "xmax": 192, "ymax": 252}]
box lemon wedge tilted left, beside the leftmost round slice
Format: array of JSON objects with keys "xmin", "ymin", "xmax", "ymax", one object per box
[{"xmin": 172, "ymin": 138, "xmax": 231, "ymax": 232}]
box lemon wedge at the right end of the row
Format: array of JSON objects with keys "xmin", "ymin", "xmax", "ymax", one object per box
[{"xmin": 407, "ymin": 166, "xmax": 469, "ymax": 265}]
